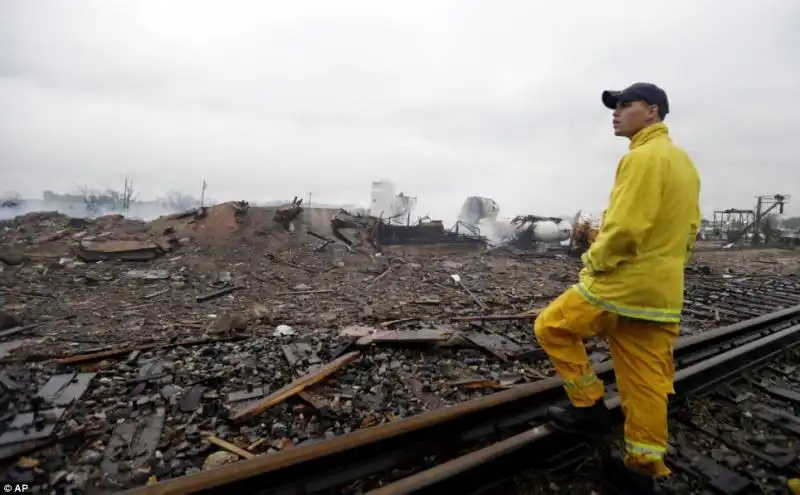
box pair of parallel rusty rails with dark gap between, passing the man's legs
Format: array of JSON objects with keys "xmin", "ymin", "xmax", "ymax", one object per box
[{"xmin": 127, "ymin": 306, "xmax": 800, "ymax": 495}]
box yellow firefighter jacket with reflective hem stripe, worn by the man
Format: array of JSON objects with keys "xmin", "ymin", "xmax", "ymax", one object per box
[{"xmin": 576, "ymin": 123, "xmax": 700, "ymax": 323}]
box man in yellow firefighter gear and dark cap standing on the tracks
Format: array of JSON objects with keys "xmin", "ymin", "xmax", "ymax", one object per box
[{"xmin": 534, "ymin": 83, "xmax": 700, "ymax": 495}]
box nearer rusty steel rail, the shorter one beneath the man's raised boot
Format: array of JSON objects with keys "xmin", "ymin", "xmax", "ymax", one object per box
[{"xmin": 367, "ymin": 324, "xmax": 800, "ymax": 495}]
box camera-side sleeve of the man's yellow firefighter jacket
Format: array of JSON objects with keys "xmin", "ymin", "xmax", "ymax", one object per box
[{"xmin": 581, "ymin": 153, "xmax": 662, "ymax": 273}]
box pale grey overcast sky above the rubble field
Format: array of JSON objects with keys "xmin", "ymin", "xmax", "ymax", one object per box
[{"xmin": 0, "ymin": 0, "xmax": 800, "ymax": 218}]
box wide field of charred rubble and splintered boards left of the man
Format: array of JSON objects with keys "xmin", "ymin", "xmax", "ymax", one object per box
[{"xmin": 0, "ymin": 206, "xmax": 796, "ymax": 492}]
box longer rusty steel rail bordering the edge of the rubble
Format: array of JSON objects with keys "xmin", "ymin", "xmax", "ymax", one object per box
[{"xmin": 125, "ymin": 305, "xmax": 800, "ymax": 495}]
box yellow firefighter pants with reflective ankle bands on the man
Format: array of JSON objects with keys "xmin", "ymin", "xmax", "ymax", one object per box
[{"xmin": 534, "ymin": 288, "xmax": 679, "ymax": 476}]
